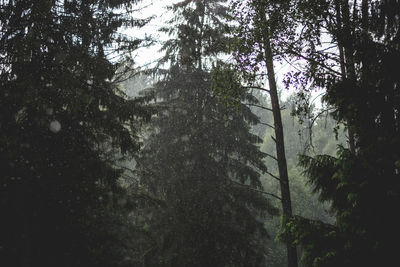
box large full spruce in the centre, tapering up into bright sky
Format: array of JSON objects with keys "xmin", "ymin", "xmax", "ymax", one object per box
[{"xmin": 139, "ymin": 1, "xmax": 275, "ymax": 266}]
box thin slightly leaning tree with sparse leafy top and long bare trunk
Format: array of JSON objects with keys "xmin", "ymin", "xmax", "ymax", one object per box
[{"xmin": 231, "ymin": 0, "xmax": 298, "ymax": 267}]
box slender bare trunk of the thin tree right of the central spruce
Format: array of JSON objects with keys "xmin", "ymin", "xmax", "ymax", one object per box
[{"xmin": 259, "ymin": 1, "xmax": 298, "ymax": 267}]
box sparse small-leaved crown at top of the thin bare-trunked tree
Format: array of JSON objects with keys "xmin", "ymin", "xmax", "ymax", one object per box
[{"xmin": 229, "ymin": 0, "xmax": 296, "ymax": 83}]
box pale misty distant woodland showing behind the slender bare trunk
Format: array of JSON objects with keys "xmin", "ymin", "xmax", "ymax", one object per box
[{"xmin": 261, "ymin": 97, "xmax": 346, "ymax": 266}]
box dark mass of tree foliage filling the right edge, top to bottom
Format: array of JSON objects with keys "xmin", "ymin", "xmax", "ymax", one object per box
[{"xmin": 276, "ymin": 1, "xmax": 400, "ymax": 266}]
